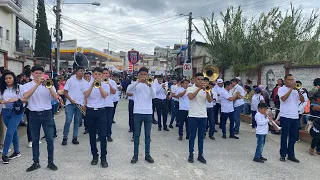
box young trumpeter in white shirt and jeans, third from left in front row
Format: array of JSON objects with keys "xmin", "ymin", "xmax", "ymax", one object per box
[{"xmin": 127, "ymin": 67, "xmax": 156, "ymax": 164}]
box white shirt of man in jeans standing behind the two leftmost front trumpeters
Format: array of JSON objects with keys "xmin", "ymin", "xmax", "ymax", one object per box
[{"xmin": 64, "ymin": 76, "xmax": 88, "ymax": 106}]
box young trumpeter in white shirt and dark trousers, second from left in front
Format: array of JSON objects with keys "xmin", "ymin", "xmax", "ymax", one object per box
[{"xmin": 84, "ymin": 67, "xmax": 110, "ymax": 168}]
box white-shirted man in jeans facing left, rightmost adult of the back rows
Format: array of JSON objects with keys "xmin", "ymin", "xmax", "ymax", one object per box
[{"xmin": 231, "ymin": 78, "xmax": 246, "ymax": 134}]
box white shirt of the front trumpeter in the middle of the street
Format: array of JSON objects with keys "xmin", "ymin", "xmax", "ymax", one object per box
[{"xmin": 127, "ymin": 82, "xmax": 156, "ymax": 114}]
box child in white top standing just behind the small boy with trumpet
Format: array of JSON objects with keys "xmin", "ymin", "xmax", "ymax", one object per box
[{"xmin": 251, "ymin": 87, "xmax": 265, "ymax": 132}]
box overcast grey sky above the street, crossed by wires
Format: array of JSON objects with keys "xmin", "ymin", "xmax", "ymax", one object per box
[{"xmin": 46, "ymin": 0, "xmax": 320, "ymax": 54}]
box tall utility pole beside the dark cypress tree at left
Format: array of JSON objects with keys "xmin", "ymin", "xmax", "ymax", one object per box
[{"xmin": 54, "ymin": 0, "xmax": 61, "ymax": 74}]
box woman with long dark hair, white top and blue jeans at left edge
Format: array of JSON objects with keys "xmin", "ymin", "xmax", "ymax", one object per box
[{"xmin": 0, "ymin": 71, "xmax": 27, "ymax": 164}]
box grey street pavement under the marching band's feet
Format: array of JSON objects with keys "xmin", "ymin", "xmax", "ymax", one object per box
[{"xmin": 0, "ymin": 99, "xmax": 320, "ymax": 180}]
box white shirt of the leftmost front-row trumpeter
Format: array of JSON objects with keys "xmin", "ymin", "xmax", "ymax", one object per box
[{"xmin": 23, "ymin": 81, "xmax": 56, "ymax": 111}]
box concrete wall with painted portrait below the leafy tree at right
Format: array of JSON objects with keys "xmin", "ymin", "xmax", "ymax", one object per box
[{"xmin": 224, "ymin": 63, "xmax": 320, "ymax": 91}]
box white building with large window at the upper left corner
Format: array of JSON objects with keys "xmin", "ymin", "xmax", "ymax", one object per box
[{"xmin": 0, "ymin": 0, "xmax": 37, "ymax": 74}]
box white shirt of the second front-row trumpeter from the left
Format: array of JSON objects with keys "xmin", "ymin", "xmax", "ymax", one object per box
[{"xmin": 85, "ymin": 82, "xmax": 113, "ymax": 108}]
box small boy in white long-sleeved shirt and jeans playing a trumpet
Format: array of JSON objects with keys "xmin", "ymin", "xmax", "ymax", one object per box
[{"xmin": 253, "ymin": 102, "xmax": 269, "ymax": 163}]
